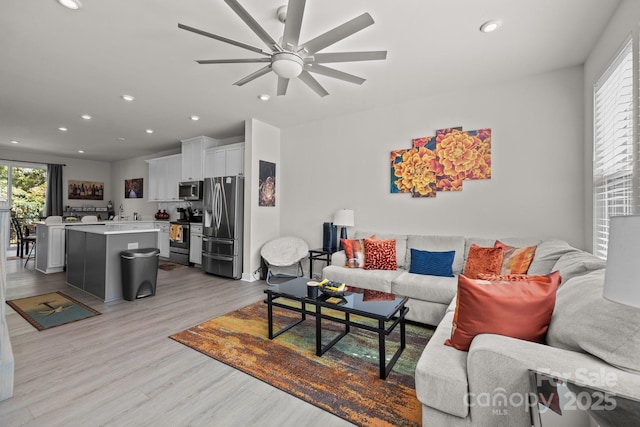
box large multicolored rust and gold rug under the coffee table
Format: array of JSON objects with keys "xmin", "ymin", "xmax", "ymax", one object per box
[{"xmin": 171, "ymin": 302, "xmax": 433, "ymax": 426}]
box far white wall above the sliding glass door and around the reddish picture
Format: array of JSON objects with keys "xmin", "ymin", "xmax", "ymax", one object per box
[{"xmin": 0, "ymin": 149, "xmax": 112, "ymax": 212}]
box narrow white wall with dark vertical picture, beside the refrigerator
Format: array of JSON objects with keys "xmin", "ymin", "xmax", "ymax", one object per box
[{"xmin": 242, "ymin": 119, "xmax": 284, "ymax": 281}]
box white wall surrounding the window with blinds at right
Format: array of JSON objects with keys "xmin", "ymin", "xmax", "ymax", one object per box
[{"xmin": 584, "ymin": 0, "xmax": 640, "ymax": 251}]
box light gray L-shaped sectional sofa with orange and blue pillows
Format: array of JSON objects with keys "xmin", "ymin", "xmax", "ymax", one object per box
[{"xmin": 323, "ymin": 232, "xmax": 640, "ymax": 427}]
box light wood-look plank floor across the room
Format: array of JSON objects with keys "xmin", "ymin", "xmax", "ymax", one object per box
[{"xmin": 0, "ymin": 260, "xmax": 352, "ymax": 427}]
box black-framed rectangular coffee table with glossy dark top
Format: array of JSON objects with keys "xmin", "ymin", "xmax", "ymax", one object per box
[{"xmin": 265, "ymin": 277, "xmax": 409, "ymax": 379}]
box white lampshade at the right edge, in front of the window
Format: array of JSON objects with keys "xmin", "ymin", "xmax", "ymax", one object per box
[{"xmin": 603, "ymin": 215, "xmax": 640, "ymax": 308}]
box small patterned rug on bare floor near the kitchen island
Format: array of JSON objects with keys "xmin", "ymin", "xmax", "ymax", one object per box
[{"xmin": 7, "ymin": 291, "xmax": 100, "ymax": 331}]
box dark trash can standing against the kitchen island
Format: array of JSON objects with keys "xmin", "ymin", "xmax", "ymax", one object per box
[{"xmin": 120, "ymin": 248, "xmax": 160, "ymax": 301}]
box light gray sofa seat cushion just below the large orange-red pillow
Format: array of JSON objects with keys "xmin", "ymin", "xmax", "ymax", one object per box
[{"xmin": 415, "ymin": 312, "xmax": 469, "ymax": 418}]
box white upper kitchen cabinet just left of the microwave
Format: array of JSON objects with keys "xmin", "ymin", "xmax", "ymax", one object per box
[{"xmin": 147, "ymin": 154, "xmax": 182, "ymax": 202}]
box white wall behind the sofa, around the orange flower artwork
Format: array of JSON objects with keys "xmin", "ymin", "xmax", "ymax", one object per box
[{"xmin": 278, "ymin": 67, "xmax": 585, "ymax": 251}]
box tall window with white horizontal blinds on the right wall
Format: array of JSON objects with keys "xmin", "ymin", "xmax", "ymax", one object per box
[{"xmin": 593, "ymin": 40, "xmax": 636, "ymax": 258}]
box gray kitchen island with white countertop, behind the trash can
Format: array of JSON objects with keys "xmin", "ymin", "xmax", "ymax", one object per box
[{"xmin": 66, "ymin": 225, "xmax": 160, "ymax": 302}]
